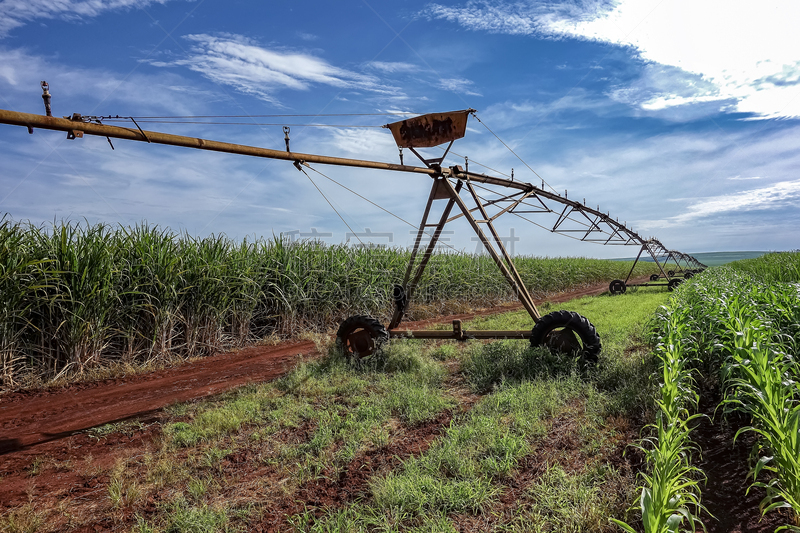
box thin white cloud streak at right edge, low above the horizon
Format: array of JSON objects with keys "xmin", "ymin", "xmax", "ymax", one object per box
[{"xmin": 673, "ymin": 180, "xmax": 800, "ymax": 223}]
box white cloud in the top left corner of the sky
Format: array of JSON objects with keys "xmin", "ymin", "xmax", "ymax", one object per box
[{"xmin": 0, "ymin": 0, "xmax": 173, "ymax": 37}]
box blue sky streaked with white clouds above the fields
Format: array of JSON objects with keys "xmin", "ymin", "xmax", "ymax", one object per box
[{"xmin": 0, "ymin": 0, "xmax": 800, "ymax": 257}]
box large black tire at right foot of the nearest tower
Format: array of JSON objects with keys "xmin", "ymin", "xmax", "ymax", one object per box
[{"xmin": 530, "ymin": 311, "xmax": 602, "ymax": 364}]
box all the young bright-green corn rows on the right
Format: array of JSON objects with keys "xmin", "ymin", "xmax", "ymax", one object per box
[{"xmin": 620, "ymin": 252, "xmax": 800, "ymax": 532}]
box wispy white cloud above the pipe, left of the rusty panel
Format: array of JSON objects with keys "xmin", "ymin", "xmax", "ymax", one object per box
[{"xmin": 157, "ymin": 34, "xmax": 399, "ymax": 104}]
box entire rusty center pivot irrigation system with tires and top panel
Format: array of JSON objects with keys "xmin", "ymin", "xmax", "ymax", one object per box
[{"xmin": 0, "ymin": 82, "xmax": 704, "ymax": 363}]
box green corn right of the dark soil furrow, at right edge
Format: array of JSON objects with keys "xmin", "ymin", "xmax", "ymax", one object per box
[{"xmin": 671, "ymin": 264, "xmax": 800, "ymax": 531}]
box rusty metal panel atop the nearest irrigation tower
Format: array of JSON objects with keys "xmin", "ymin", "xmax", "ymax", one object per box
[{"xmin": 384, "ymin": 109, "xmax": 472, "ymax": 148}]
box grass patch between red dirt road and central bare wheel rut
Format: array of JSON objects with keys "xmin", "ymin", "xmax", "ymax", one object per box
[{"xmin": 129, "ymin": 341, "xmax": 455, "ymax": 531}]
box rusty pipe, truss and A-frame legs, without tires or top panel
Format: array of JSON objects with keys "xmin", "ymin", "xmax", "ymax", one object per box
[{"xmin": 0, "ymin": 104, "xmax": 705, "ymax": 353}]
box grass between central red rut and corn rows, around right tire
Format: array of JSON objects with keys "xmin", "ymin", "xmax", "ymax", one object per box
[{"xmin": 293, "ymin": 291, "xmax": 668, "ymax": 531}]
